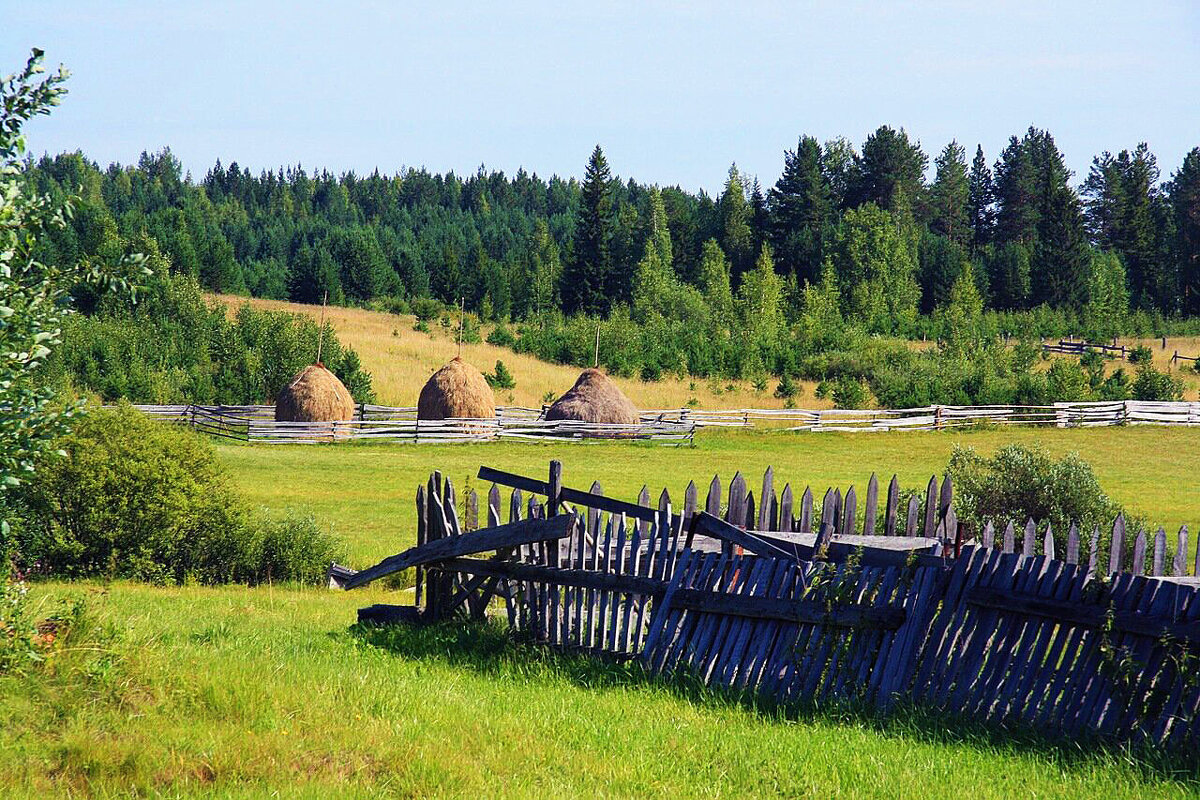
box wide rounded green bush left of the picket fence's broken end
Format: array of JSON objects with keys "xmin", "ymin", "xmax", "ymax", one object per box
[{"xmin": 7, "ymin": 404, "xmax": 338, "ymax": 584}]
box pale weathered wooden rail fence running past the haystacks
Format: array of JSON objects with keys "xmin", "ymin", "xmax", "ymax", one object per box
[{"xmin": 136, "ymin": 401, "xmax": 1200, "ymax": 444}]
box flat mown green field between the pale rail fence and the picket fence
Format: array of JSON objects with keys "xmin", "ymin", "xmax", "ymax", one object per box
[{"xmin": 220, "ymin": 427, "xmax": 1200, "ymax": 566}]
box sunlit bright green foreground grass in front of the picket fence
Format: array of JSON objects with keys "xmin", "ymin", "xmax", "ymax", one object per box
[{"xmin": 0, "ymin": 584, "xmax": 1194, "ymax": 799}]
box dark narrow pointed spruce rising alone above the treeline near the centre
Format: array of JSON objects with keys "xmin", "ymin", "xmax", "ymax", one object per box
[{"xmin": 562, "ymin": 145, "xmax": 612, "ymax": 313}]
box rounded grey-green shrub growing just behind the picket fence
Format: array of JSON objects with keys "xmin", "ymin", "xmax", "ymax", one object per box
[{"xmin": 947, "ymin": 445, "xmax": 1122, "ymax": 556}]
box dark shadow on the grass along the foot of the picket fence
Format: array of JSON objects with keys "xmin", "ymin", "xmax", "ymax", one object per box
[{"xmin": 350, "ymin": 621, "xmax": 1200, "ymax": 787}]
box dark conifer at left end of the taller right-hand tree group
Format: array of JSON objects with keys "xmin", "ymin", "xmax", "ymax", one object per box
[{"xmin": 768, "ymin": 137, "xmax": 834, "ymax": 281}]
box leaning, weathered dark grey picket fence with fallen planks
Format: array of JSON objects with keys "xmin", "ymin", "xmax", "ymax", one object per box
[{"xmin": 331, "ymin": 462, "xmax": 1200, "ymax": 747}]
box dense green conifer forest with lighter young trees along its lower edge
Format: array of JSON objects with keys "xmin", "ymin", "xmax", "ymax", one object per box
[{"xmin": 28, "ymin": 126, "xmax": 1200, "ymax": 407}]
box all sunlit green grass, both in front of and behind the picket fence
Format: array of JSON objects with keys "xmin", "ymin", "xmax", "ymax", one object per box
[{"xmin": 7, "ymin": 428, "xmax": 1200, "ymax": 798}]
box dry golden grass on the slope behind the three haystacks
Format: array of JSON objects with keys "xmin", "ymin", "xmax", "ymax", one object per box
[{"xmin": 211, "ymin": 295, "xmax": 830, "ymax": 409}]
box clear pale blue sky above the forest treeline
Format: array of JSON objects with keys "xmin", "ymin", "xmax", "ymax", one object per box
[{"xmin": 0, "ymin": 0, "xmax": 1200, "ymax": 192}]
